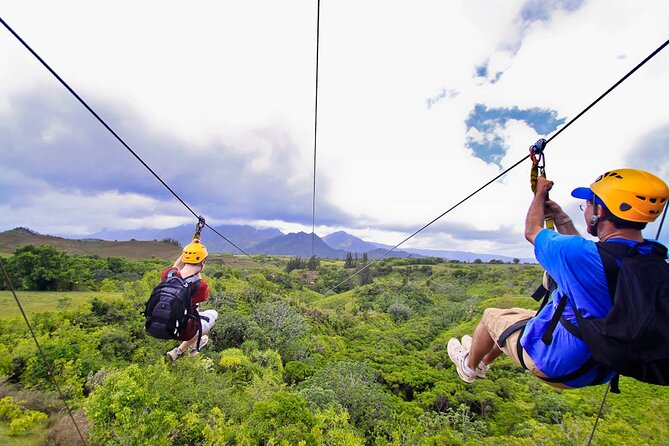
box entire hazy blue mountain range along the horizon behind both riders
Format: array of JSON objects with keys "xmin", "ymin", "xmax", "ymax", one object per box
[{"xmin": 87, "ymin": 225, "xmax": 535, "ymax": 263}]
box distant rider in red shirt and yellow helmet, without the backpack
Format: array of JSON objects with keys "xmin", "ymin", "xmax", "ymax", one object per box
[{"xmin": 161, "ymin": 239, "xmax": 218, "ymax": 361}]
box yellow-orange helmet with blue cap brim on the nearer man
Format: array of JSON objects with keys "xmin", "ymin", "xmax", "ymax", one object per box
[{"xmin": 571, "ymin": 169, "xmax": 669, "ymax": 223}]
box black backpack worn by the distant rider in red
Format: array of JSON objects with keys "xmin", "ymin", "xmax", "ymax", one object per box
[{"xmin": 144, "ymin": 270, "xmax": 202, "ymax": 346}]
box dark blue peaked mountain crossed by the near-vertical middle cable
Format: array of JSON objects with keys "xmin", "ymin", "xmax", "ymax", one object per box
[{"xmin": 250, "ymin": 232, "xmax": 347, "ymax": 259}]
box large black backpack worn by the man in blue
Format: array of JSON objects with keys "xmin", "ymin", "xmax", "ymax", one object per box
[{"xmin": 576, "ymin": 242, "xmax": 669, "ymax": 386}]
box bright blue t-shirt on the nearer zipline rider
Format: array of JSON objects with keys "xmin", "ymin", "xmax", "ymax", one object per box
[{"xmin": 521, "ymin": 229, "xmax": 644, "ymax": 387}]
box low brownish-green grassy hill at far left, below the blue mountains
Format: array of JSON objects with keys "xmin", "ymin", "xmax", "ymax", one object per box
[{"xmin": 0, "ymin": 228, "xmax": 181, "ymax": 259}]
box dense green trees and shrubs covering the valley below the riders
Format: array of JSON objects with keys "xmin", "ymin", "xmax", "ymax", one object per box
[{"xmin": 0, "ymin": 247, "xmax": 669, "ymax": 445}]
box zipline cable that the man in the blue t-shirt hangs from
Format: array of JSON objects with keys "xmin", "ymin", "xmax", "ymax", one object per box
[{"xmin": 328, "ymin": 39, "xmax": 669, "ymax": 292}]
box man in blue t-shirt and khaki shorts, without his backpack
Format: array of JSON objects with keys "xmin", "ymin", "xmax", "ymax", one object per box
[{"xmin": 448, "ymin": 169, "xmax": 669, "ymax": 388}]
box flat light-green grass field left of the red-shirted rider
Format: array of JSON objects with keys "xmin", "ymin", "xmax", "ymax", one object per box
[{"xmin": 0, "ymin": 291, "xmax": 123, "ymax": 319}]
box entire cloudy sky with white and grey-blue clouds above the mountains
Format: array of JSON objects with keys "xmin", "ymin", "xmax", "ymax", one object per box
[{"xmin": 0, "ymin": 0, "xmax": 669, "ymax": 257}]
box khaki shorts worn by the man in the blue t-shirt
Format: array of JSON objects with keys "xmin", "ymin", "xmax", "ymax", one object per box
[{"xmin": 481, "ymin": 308, "xmax": 566, "ymax": 388}]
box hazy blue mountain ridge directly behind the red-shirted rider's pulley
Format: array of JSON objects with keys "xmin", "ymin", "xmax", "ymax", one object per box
[{"xmin": 90, "ymin": 224, "xmax": 283, "ymax": 254}]
